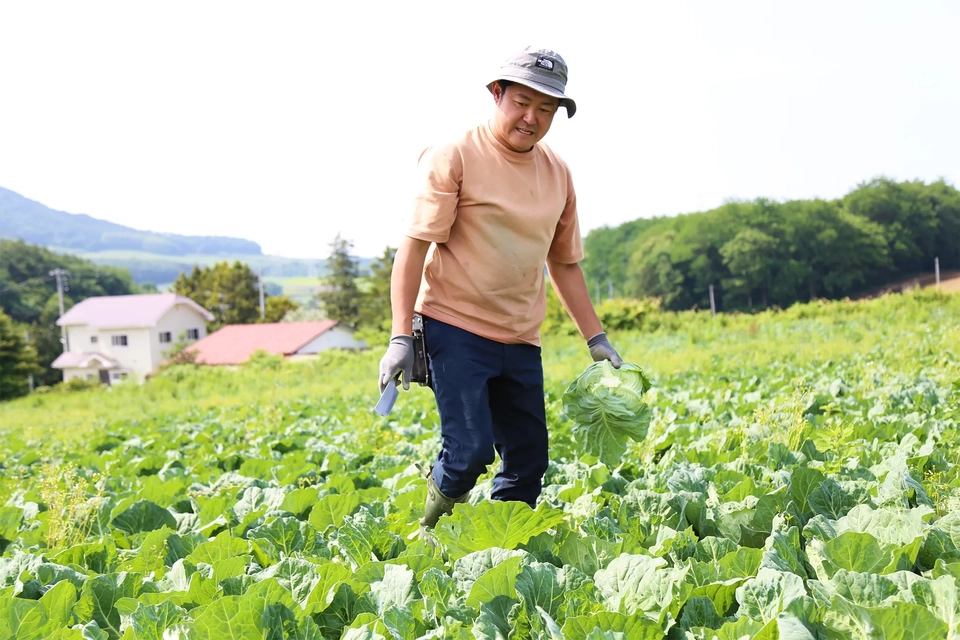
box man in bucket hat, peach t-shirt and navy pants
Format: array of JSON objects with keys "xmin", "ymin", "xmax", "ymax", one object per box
[{"xmin": 380, "ymin": 47, "xmax": 621, "ymax": 528}]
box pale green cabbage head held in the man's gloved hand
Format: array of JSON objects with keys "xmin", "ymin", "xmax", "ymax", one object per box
[{"xmin": 563, "ymin": 360, "xmax": 653, "ymax": 466}]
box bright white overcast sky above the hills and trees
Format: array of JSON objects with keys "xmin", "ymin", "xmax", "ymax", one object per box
[{"xmin": 0, "ymin": 0, "xmax": 960, "ymax": 258}]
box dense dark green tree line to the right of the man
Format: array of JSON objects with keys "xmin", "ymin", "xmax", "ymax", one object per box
[{"xmin": 583, "ymin": 178, "xmax": 960, "ymax": 310}]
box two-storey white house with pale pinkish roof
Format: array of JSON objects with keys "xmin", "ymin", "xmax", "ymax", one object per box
[{"xmin": 53, "ymin": 293, "xmax": 214, "ymax": 384}]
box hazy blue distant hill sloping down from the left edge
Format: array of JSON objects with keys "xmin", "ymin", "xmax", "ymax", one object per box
[{"xmin": 0, "ymin": 187, "xmax": 263, "ymax": 256}]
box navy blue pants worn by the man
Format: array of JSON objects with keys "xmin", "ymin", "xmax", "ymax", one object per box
[{"xmin": 423, "ymin": 317, "xmax": 548, "ymax": 507}]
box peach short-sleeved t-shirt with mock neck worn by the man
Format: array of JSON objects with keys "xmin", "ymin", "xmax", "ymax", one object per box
[{"xmin": 407, "ymin": 124, "xmax": 583, "ymax": 345}]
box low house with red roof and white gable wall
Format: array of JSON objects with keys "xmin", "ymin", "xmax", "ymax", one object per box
[{"xmin": 186, "ymin": 320, "xmax": 367, "ymax": 365}]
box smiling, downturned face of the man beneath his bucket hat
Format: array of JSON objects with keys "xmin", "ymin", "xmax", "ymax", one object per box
[{"xmin": 493, "ymin": 84, "xmax": 560, "ymax": 153}]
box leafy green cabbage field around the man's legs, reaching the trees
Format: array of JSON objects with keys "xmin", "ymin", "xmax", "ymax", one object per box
[{"xmin": 0, "ymin": 293, "xmax": 960, "ymax": 640}]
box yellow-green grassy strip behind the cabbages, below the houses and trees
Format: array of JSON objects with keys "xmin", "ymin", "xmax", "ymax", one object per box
[{"xmin": 0, "ymin": 291, "xmax": 960, "ymax": 441}]
